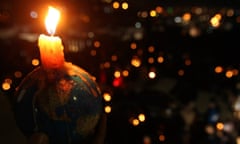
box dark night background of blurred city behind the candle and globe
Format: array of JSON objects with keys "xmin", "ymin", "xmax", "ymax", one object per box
[{"xmin": 0, "ymin": 0, "xmax": 240, "ymax": 144}]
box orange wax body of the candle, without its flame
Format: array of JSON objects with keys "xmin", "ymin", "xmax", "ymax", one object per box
[{"xmin": 38, "ymin": 34, "xmax": 64, "ymax": 69}]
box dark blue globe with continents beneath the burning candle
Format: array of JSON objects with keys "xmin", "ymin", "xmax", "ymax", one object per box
[{"xmin": 14, "ymin": 62, "xmax": 102, "ymax": 144}]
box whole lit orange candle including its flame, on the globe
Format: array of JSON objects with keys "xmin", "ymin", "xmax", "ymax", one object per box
[{"xmin": 38, "ymin": 7, "xmax": 65, "ymax": 69}]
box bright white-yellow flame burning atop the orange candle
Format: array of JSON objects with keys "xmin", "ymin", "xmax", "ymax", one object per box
[{"xmin": 45, "ymin": 6, "xmax": 60, "ymax": 35}]
